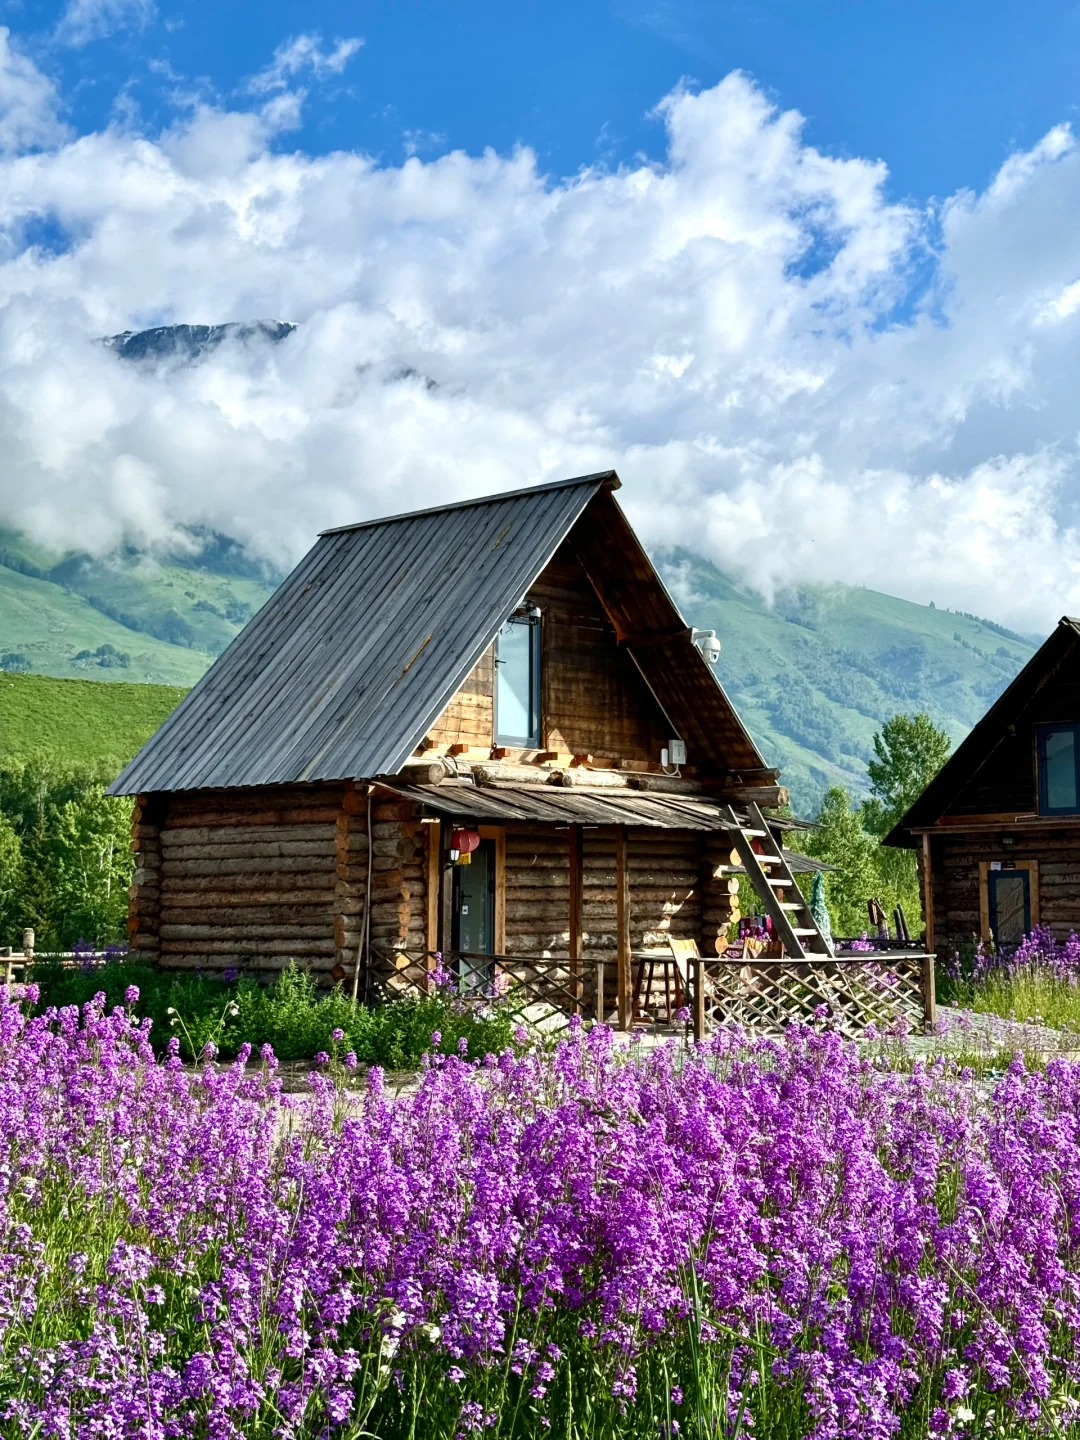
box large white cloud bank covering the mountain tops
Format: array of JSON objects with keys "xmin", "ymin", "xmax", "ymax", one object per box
[{"xmin": 0, "ymin": 64, "xmax": 1080, "ymax": 629}]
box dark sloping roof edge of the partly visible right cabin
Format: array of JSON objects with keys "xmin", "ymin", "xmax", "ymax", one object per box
[{"xmin": 884, "ymin": 615, "xmax": 1080, "ymax": 848}]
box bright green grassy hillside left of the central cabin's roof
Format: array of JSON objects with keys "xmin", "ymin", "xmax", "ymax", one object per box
[{"xmin": 0, "ymin": 674, "xmax": 184, "ymax": 769}]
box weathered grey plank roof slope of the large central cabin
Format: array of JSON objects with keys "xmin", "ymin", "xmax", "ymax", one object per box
[{"xmin": 111, "ymin": 472, "xmax": 618, "ymax": 795}]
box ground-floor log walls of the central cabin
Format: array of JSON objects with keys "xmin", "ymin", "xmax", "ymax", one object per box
[{"xmin": 130, "ymin": 786, "xmax": 714, "ymax": 985}]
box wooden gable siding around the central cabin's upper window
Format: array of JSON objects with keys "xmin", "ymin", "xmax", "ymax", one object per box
[{"xmin": 417, "ymin": 544, "xmax": 671, "ymax": 765}]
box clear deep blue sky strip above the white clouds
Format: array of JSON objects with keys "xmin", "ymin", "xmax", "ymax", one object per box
[{"xmin": 12, "ymin": 0, "xmax": 1080, "ymax": 200}]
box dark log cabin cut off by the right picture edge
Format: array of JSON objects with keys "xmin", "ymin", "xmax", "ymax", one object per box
[{"xmin": 886, "ymin": 616, "xmax": 1080, "ymax": 950}]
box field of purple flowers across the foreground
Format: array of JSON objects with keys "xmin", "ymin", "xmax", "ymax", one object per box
[{"xmin": 0, "ymin": 995, "xmax": 1080, "ymax": 1440}]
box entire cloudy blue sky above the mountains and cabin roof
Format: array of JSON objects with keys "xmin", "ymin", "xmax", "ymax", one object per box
[{"xmin": 0, "ymin": 0, "xmax": 1080, "ymax": 632}]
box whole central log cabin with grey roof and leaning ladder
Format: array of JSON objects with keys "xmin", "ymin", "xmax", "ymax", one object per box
[{"xmin": 112, "ymin": 472, "xmax": 828, "ymax": 1022}]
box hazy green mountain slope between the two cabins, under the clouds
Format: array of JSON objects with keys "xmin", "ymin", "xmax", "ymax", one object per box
[{"xmin": 661, "ymin": 552, "xmax": 1037, "ymax": 814}]
